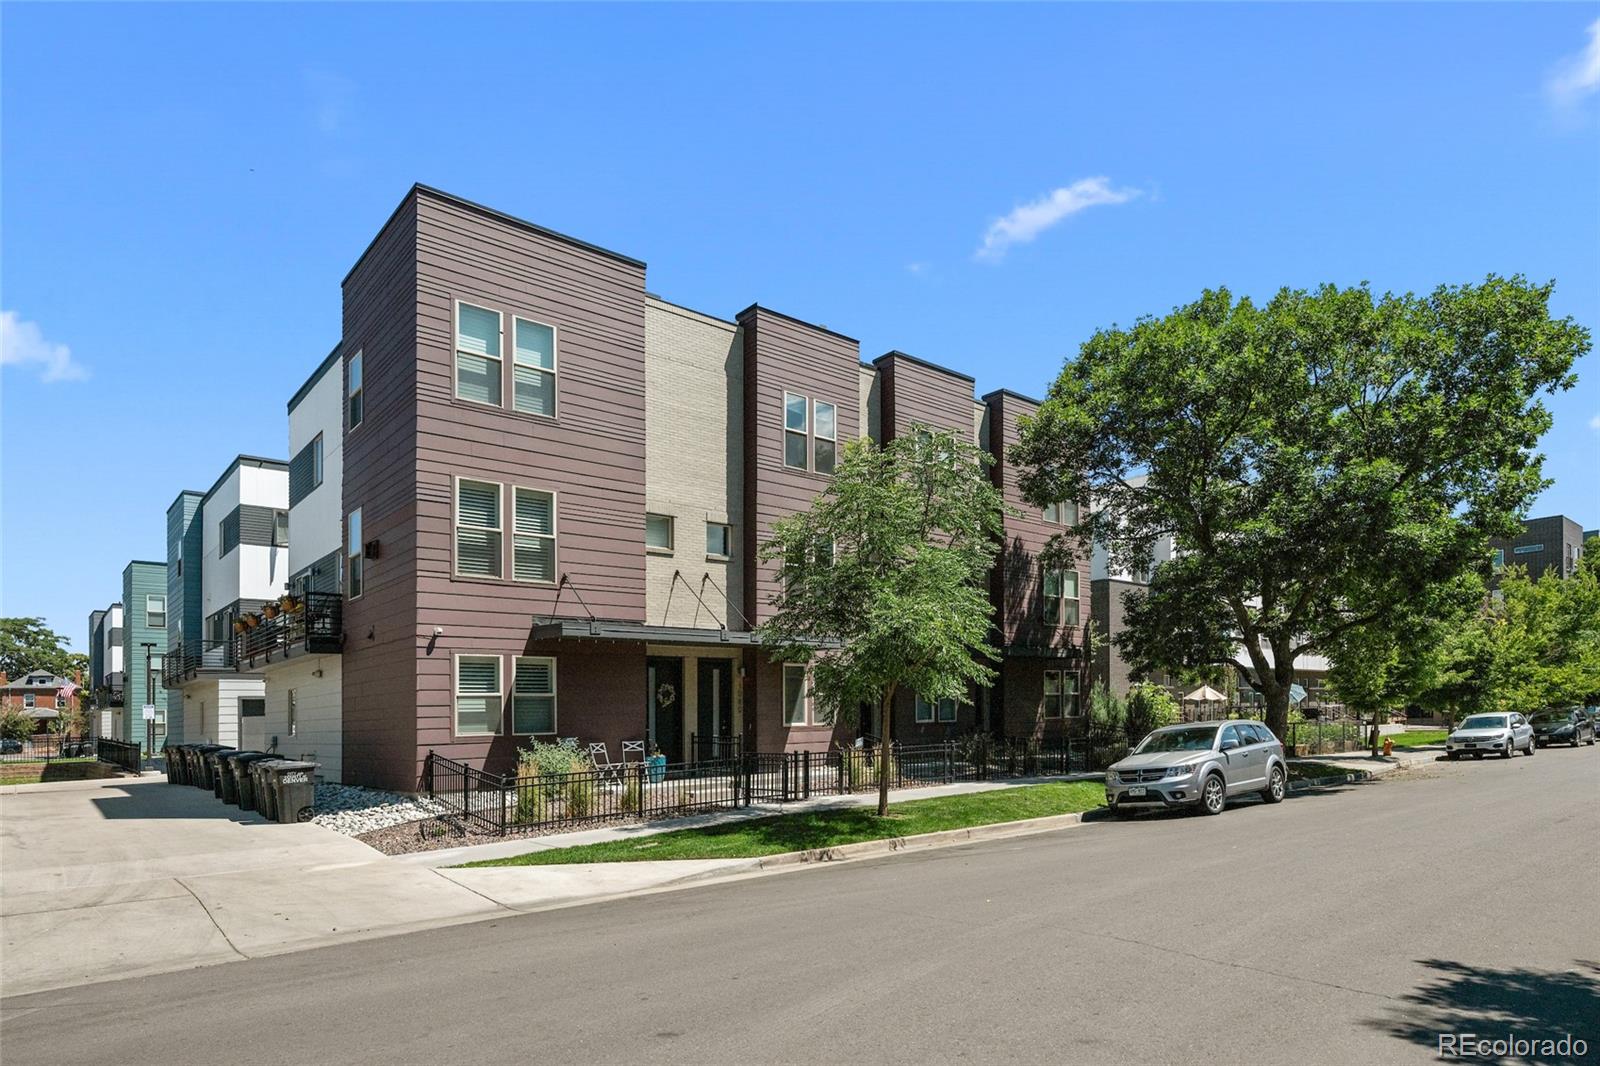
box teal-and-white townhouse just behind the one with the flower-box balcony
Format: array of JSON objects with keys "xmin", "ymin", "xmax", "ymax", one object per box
[{"xmin": 163, "ymin": 455, "xmax": 290, "ymax": 746}]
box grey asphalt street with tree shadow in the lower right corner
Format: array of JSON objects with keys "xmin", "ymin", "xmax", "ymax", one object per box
[{"xmin": 0, "ymin": 747, "xmax": 1600, "ymax": 1066}]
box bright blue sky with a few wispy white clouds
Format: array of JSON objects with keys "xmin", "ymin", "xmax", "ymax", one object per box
[{"xmin": 0, "ymin": 3, "xmax": 1600, "ymax": 648}]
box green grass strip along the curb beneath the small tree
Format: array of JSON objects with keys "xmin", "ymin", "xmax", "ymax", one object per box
[{"xmin": 466, "ymin": 781, "xmax": 1106, "ymax": 866}]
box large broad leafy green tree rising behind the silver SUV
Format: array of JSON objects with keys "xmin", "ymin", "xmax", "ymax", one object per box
[{"xmin": 1013, "ymin": 277, "xmax": 1589, "ymax": 733}]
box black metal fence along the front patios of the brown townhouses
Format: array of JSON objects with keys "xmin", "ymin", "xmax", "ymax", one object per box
[{"xmin": 422, "ymin": 733, "xmax": 1128, "ymax": 836}]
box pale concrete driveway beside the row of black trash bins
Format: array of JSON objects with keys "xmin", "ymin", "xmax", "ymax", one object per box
[{"xmin": 0, "ymin": 775, "xmax": 506, "ymax": 996}]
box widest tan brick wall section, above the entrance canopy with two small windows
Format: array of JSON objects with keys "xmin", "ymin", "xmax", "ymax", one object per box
[{"xmin": 645, "ymin": 298, "xmax": 747, "ymax": 629}]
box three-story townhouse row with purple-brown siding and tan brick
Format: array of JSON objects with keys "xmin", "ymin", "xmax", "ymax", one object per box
[{"xmin": 321, "ymin": 186, "xmax": 1088, "ymax": 789}]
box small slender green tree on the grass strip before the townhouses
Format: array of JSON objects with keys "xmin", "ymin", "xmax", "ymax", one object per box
[{"xmin": 760, "ymin": 429, "xmax": 1003, "ymax": 816}]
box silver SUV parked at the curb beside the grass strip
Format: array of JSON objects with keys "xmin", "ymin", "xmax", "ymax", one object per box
[{"xmin": 1106, "ymin": 722, "xmax": 1290, "ymax": 816}]
